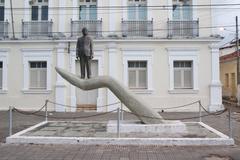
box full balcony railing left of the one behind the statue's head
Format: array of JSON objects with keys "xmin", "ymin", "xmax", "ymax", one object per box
[{"xmin": 22, "ymin": 21, "xmax": 53, "ymax": 38}]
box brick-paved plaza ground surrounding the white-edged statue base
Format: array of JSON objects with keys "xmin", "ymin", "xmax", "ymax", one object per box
[{"xmin": 0, "ymin": 108, "xmax": 240, "ymax": 160}]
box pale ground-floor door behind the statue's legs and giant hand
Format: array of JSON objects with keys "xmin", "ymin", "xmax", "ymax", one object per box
[{"xmin": 76, "ymin": 60, "xmax": 98, "ymax": 111}]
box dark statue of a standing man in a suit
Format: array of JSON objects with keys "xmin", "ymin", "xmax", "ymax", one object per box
[{"xmin": 76, "ymin": 27, "xmax": 93, "ymax": 79}]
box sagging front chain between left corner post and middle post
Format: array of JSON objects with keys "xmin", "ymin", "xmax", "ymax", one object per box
[{"xmin": 13, "ymin": 107, "xmax": 117, "ymax": 119}]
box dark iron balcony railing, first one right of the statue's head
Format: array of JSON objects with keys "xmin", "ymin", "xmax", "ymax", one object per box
[{"xmin": 122, "ymin": 20, "xmax": 153, "ymax": 37}]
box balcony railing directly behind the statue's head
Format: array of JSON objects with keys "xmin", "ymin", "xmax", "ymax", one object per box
[{"xmin": 71, "ymin": 20, "xmax": 102, "ymax": 38}]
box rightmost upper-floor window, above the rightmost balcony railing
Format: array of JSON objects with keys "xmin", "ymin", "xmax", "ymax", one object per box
[{"xmin": 173, "ymin": 0, "xmax": 192, "ymax": 20}]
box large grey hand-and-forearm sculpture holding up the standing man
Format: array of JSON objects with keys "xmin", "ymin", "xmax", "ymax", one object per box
[{"xmin": 56, "ymin": 67, "xmax": 163, "ymax": 124}]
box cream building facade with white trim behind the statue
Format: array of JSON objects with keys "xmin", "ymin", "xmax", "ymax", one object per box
[{"xmin": 0, "ymin": 0, "xmax": 222, "ymax": 112}]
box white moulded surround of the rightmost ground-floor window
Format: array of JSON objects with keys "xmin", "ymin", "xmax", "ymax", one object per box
[{"xmin": 166, "ymin": 48, "xmax": 200, "ymax": 94}]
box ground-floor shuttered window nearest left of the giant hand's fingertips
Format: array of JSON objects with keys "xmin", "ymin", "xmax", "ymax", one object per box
[{"xmin": 29, "ymin": 61, "xmax": 47, "ymax": 89}]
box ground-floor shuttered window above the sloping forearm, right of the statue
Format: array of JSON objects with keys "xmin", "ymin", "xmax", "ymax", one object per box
[{"xmin": 128, "ymin": 61, "xmax": 147, "ymax": 89}]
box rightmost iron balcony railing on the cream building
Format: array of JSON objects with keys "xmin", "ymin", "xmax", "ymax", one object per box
[{"xmin": 167, "ymin": 20, "xmax": 199, "ymax": 38}]
